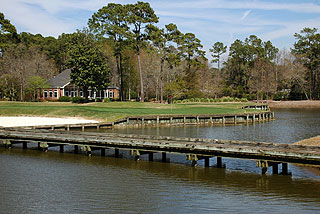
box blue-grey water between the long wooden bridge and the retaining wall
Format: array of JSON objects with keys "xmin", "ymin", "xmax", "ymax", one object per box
[{"xmin": 99, "ymin": 109, "xmax": 320, "ymax": 143}]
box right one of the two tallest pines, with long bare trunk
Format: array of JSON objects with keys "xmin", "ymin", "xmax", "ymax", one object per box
[{"xmin": 127, "ymin": 1, "xmax": 159, "ymax": 102}]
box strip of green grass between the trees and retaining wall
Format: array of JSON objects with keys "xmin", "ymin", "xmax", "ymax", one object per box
[{"xmin": 0, "ymin": 102, "xmax": 257, "ymax": 122}]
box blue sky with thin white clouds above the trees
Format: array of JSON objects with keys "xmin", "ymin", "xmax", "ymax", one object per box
[{"xmin": 0, "ymin": 0, "xmax": 320, "ymax": 59}]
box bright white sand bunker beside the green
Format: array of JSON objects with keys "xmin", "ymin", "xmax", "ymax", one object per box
[{"xmin": 0, "ymin": 117, "xmax": 98, "ymax": 127}]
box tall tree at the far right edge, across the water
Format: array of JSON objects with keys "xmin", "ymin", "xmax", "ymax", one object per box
[{"xmin": 292, "ymin": 28, "xmax": 320, "ymax": 99}]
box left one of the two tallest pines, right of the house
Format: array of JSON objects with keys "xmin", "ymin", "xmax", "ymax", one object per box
[{"xmin": 88, "ymin": 3, "xmax": 129, "ymax": 100}]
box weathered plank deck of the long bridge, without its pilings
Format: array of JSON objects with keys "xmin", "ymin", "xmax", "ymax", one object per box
[{"xmin": 0, "ymin": 130, "xmax": 320, "ymax": 165}]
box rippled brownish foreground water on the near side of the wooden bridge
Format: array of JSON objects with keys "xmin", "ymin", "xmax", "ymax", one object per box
[{"xmin": 0, "ymin": 148, "xmax": 320, "ymax": 213}]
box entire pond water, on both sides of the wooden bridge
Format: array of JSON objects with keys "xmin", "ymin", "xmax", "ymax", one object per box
[{"xmin": 0, "ymin": 109, "xmax": 320, "ymax": 214}]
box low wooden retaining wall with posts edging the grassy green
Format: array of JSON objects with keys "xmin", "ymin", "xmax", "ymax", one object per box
[{"xmin": 19, "ymin": 111, "xmax": 274, "ymax": 131}]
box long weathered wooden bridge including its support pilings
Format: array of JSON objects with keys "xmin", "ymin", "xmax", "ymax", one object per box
[{"xmin": 0, "ymin": 129, "xmax": 320, "ymax": 174}]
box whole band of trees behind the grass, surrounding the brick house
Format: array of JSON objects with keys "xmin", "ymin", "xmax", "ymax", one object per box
[{"xmin": 0, "ymin": 2, "xmax": 320, "ymax": 102}]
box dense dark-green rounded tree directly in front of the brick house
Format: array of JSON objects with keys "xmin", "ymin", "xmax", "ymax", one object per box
[{"xmin": 68, "ymin": 31, "xmax": 110, "ymax": 100}]
